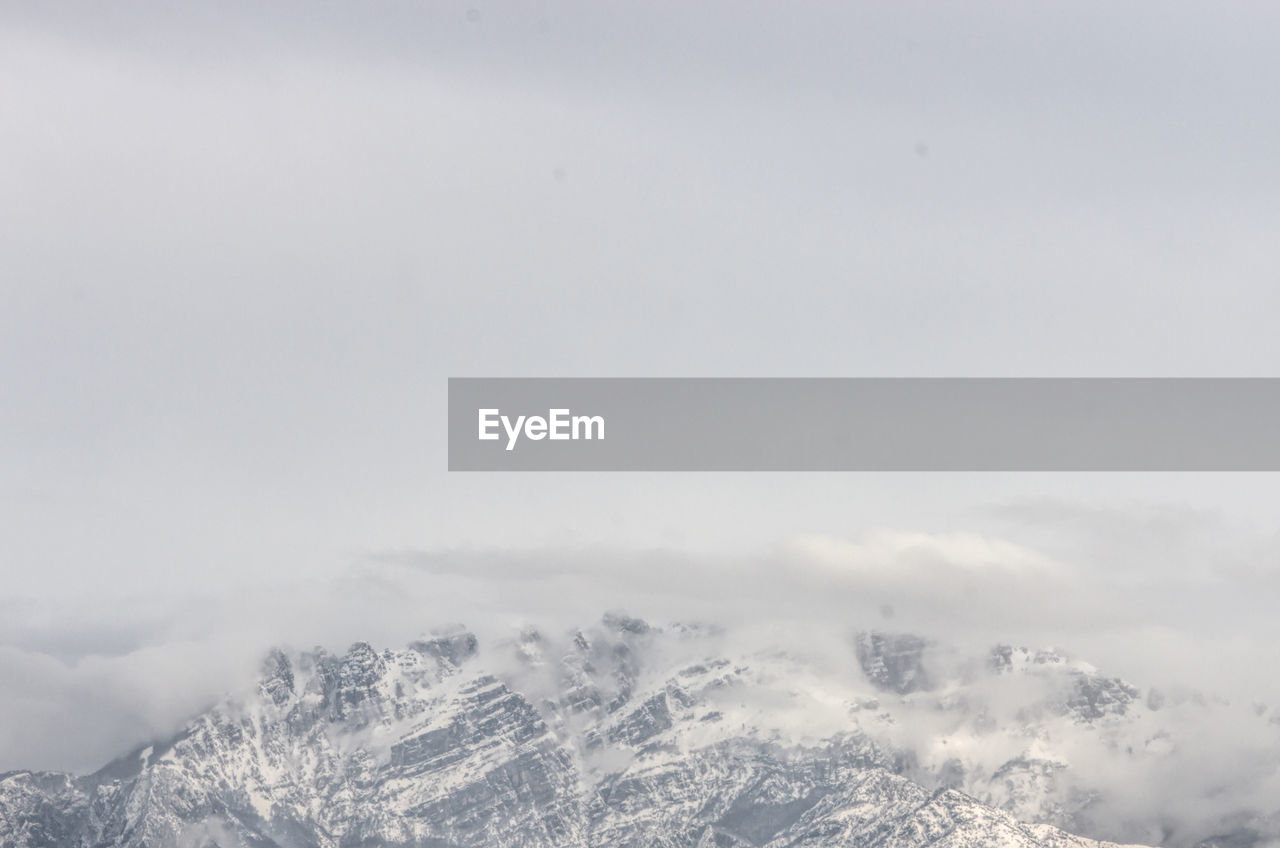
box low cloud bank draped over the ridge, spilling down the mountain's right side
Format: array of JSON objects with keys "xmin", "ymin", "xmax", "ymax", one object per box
[{"xmin": 0, "ymin": 516, "xmax": 1280, "ymax": 840}]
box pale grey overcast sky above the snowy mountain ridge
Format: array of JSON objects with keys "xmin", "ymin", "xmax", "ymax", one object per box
[{"xmin": 0, "ymin": 0, "xmax": 1280, "ymax": 783}]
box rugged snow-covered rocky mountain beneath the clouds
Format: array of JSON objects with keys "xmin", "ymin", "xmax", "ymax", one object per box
[{"xmin": 0, "ymin": 615, "xmax": 1247, "ymax": 848}]
